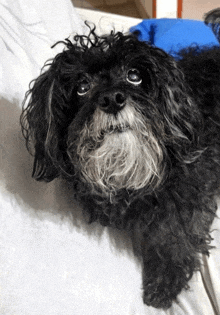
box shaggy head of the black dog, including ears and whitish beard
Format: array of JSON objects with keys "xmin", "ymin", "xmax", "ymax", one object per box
[{"xmin": 21, "ymin": 26, "xmax": 200, "ymax": 202}]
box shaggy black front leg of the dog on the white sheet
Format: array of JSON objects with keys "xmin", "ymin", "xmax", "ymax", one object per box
[{"xmin": 133, "ymin": 193, "xmax": 216, "ymax": 309}]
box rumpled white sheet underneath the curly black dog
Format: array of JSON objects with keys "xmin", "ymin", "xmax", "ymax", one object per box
[{"xmin": 0, "ymin": 0, "xmax": 220, "ymax": 315}]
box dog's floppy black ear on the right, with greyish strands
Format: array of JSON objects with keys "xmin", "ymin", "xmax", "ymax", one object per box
[{"xmin": 141, "ymin": 48, "xmax": 203, "ymax": 163}]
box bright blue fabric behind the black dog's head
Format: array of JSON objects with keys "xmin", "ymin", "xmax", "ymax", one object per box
[{"xmin": 130, "ymin": 18, "xmax": 219, "ymax": 58}]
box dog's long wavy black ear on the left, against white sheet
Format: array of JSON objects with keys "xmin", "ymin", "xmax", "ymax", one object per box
[{"xmin": 21, "ymin": 52, "xmax": 79, "ymax": 181}]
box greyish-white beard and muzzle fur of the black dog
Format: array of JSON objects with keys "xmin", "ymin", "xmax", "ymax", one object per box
[{"xmin": 69, "ymin": 102, "xmax": 163, "ymax": 196}]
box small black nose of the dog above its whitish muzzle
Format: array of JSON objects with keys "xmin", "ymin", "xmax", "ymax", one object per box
[{"xmin": 98, "ymin": 91, "xmax": 126, "ymax": 114}]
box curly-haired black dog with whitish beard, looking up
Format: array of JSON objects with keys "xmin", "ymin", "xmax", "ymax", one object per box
[{"xmin": 21, "ymin": 13, "xmax": 220, "ymax": 309}]
